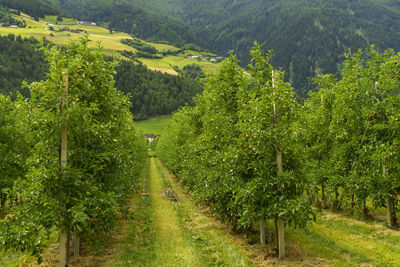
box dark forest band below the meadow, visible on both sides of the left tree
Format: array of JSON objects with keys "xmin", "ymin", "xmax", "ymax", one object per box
[{"xmin": 0, "ymin": 35, "xmax": 204, "ymax": 119}]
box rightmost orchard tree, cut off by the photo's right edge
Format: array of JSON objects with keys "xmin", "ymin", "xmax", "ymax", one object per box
[{"xmin": 363, "ymin": 49, "xmax": 400, "ymax": 226}]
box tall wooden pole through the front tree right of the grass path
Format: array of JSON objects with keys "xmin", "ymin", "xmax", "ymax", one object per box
[{"xmin": 272, "ymin": 70, "xmax": 285, "ymax": 259}]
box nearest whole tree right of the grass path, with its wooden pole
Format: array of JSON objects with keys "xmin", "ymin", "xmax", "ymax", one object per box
[{"xmin": 239, "ymin": 43, "xmax": 313, "ymax": 258}]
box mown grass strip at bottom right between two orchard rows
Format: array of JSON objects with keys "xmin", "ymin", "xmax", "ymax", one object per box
[{"xmin": 289, "ymin": 212, "xmax": 400, "ymax": 266}]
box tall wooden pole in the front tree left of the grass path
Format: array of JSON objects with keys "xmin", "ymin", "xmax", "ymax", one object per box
[{"xmin": 59, "ymin": 69, "xmax": 70, "ymax": 267}]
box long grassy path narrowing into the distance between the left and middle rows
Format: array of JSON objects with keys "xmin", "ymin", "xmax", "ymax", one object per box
[{"xmin": 109, "ymin": 158, "xmax": 252, "ymax": 266}]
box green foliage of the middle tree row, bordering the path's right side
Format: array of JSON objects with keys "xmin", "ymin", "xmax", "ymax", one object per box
[{"xmin": 158, "ymin": 44, "xmax": 313, "ymax": 232}]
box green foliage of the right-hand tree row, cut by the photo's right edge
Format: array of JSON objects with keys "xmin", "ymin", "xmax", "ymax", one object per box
[{"xmin": 304, "ymin": 47, "xmax": 400, "ymax": 220}]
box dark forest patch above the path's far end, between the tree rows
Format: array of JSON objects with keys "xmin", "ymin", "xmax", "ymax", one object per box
[{"xmin": 115, "ymin": 61, "xmax": 202, "ymax": 120}]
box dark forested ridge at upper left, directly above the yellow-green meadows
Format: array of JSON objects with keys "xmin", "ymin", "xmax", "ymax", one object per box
[{"xmin": 43, "ymin": 0, "xmax": 205, "ymax": 46}]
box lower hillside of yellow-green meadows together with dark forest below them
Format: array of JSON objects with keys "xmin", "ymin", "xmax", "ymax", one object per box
[{"xmin": 0, "ymin": 9, "xmax": 209, "ymax": 120}]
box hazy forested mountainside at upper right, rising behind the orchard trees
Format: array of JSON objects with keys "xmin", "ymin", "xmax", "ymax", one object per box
[{"xmin": 92, "ymin": 0, "xmax": 400, "ymax": 96}]
